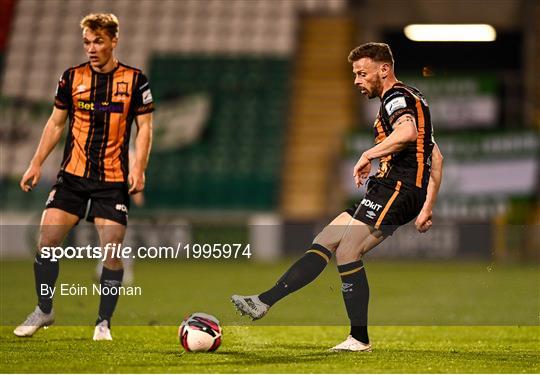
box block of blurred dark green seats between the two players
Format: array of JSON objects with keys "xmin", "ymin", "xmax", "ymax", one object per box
[{"xmin": 147, "ymin": 55, "xmax": 289, "ymax": 209}]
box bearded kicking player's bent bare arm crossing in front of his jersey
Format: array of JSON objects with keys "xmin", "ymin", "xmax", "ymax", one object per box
[{"xmin": 353, "ymin": 113, "xmax": 418, "ymax": 186}]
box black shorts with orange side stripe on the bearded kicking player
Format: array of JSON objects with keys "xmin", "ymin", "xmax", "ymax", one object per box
[{"xmin": 345, "ymin": 177, "xmax": 426, "ymax": 236}]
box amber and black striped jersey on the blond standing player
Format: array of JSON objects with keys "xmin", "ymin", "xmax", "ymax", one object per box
[{"xmin": 54, "ymin": 62, "xmax": 154, "ymax": 182}]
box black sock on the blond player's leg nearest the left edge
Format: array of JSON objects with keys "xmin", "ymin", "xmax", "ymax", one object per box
[{"xmin": 34, "ymin": 254, "xmax": 60, "ymax": 314}]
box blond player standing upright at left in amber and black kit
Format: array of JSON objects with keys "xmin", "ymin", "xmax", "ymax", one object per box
[{"xmin": 14, "ymin": 14, "xmax": 154, "ymax": 340}]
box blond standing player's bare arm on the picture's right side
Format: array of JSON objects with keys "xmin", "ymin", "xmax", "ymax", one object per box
[{"xmin": 128, "ymin": 112, "xmax": 153, "ymax": 194}]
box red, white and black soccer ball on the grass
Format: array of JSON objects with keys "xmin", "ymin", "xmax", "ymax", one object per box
[{"xmin": 178, "ymin": 313, "xmax": 221, "ymax": 352}]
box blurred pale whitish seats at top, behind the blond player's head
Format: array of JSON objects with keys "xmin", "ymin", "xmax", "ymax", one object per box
[{"xmin": 2, "ymin": 0, "xmax": 346, "ymax": 100}]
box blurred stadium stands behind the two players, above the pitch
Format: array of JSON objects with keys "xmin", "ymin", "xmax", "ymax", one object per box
[{"xmin": 0, "ymin": 0, "xmax": 540, "ymax": 261}]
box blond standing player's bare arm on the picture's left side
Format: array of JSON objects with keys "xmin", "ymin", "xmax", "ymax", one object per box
[{"xmin": 19, "ymin": 107, "xmax": 68, "ymax": 192}]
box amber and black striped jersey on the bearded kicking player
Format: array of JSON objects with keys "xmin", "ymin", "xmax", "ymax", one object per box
[{"xmin": 373, "ymin": 82, "xmax": 434, "ymax": 189}]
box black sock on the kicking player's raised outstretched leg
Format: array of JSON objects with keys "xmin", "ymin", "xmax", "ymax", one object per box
[{"xmin": 259, "ymin": 244, "xmax": 332, "ymax": 306}]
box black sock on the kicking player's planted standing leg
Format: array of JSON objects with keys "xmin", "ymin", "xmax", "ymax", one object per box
[{"xmin": 338, "ymin": 260, "xmax": 369, "ymax": 344}]
